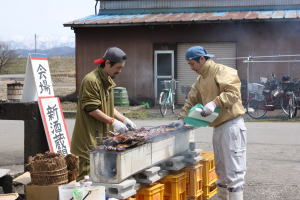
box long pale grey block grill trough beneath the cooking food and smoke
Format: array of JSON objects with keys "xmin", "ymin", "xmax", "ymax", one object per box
[{"xmin": 90, "ymin": 127, "xmax": 193, "ymax": 183}]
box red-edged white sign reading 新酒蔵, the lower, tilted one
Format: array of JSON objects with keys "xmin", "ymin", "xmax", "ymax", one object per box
[{"xmin": 38, "ymin": 97, "xmax": 70, "ymax": 155}]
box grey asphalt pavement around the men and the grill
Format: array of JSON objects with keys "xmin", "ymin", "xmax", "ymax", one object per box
[{"xmin": 0, "ymin": 119, "xmax": 300, "ymax": 200}]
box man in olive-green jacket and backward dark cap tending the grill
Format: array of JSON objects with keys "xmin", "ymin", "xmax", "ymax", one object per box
[{"xmin": 71, "ymin": 47, "xmax": 136, "ymax": 180}]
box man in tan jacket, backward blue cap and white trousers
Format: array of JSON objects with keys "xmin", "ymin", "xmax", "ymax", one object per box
[{"xmin": 179, "ymin": 46, "xmax": 246, "ymax": 200}]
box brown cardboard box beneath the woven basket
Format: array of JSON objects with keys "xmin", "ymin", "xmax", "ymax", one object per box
[{"xmin": 25, "ymin": 185, "xmax": 59, "ymax": 200}]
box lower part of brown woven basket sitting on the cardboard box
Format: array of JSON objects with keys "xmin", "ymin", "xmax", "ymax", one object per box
[{"xmin": 31, "ymin": 167, "xmax": 68, "ymax": 185}]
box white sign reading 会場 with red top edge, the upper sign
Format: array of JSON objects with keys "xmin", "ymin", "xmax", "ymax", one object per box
[{"xmin": 22, "ymin": 54, "xmax": 54, "ymax": 102}]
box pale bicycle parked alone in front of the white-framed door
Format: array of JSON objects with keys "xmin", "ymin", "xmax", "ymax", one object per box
[{"xmin": 158, "ymin": 79, "xmax": 179, "ymax": 117}]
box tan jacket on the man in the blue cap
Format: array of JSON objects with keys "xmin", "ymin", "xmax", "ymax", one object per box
[{"xmin": 179, "ymin": 59, "xmax": 245, "ymax": 127}]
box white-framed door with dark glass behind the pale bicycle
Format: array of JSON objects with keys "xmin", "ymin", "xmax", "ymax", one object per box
[{"xmin": 154, "ymin": 50, "xmax": 174, "ymax": 102}]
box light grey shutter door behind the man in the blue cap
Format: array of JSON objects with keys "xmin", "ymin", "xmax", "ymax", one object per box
[{"xmin": 176, "ymin": 43, "xmax": 236, "ymax": 104}]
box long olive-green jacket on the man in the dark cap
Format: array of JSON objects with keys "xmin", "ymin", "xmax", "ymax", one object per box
[{"xmin": 71, "ymin": 67, "xmax": 115, "ymax": 160}]
